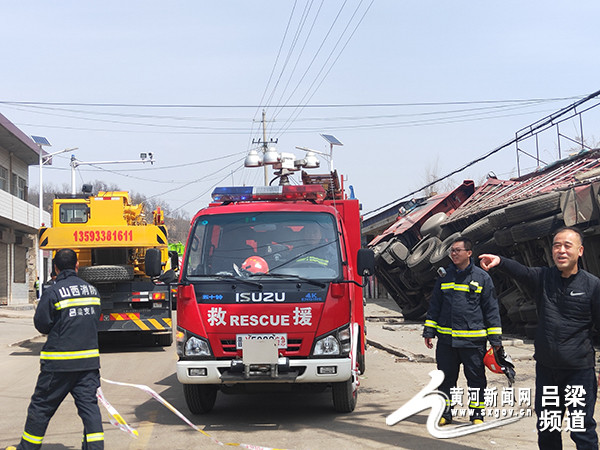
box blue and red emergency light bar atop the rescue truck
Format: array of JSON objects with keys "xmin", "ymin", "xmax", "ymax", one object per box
[{"xmin": 212, "ymin": 185, "xmax": 325, "ymax": 202}]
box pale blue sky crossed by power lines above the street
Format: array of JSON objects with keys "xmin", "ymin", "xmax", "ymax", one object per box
[{"xmin": 0, "ymin": 0, "xmax": 600, "ymax": 220}]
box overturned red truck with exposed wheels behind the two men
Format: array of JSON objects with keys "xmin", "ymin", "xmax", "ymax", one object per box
[{"xmin": 369, "ymin": 149, "xmax": 600, "ymax": 337}]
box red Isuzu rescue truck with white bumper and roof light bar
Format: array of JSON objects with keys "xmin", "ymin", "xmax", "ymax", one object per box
[{"xmin": 177, "ymin": 181, "xmax": 373, "ymax": 414}]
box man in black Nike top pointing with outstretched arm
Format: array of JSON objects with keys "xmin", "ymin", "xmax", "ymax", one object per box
[{"xmin": 479, "ymin": 227, "xmax": 600, "ymax": 450}]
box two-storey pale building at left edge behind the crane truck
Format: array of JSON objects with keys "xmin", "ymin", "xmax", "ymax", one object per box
[{"xmin": 0, "ymin": 114, "xmax": 50, "ymax": 305}]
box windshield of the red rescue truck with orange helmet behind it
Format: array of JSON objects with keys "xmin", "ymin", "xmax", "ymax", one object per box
[{"xmin": 183, "ymin": 212, "xmax": 341, "ymax": 280}]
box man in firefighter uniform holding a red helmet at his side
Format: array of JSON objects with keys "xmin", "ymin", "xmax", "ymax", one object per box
[{"xmin": 423, "ymin": 237, "xmax": 502, "ymax": 425}]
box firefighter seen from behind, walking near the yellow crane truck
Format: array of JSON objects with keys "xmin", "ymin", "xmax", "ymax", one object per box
[{"xmin": 9, "ymin": 249, "xmax": 104, "ymax": 450}]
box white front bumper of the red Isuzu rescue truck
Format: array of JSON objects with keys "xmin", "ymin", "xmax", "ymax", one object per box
[{"xmin": 177, "ymin": 358, "xmax": 352, "ymax": 384}]
